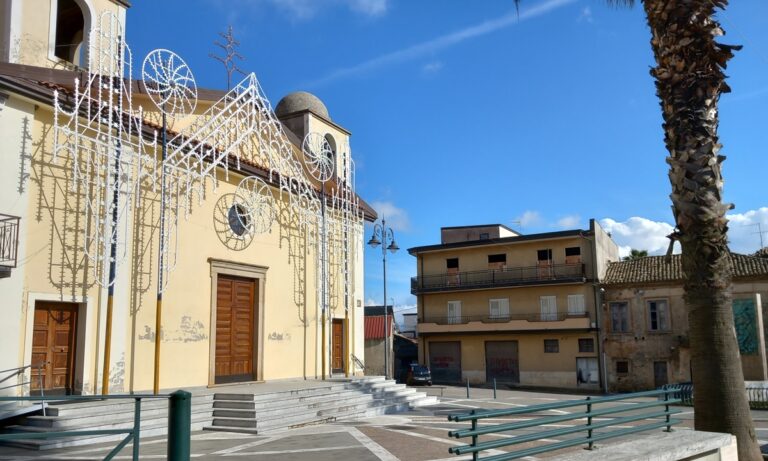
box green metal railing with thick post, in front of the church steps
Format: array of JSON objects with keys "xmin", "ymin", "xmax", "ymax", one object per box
[{"xmin": 0, "ymin": 391, "xmax": 192, "ymax": 461}]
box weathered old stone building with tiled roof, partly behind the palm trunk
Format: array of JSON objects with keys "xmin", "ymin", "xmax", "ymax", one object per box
[{"xmin": 602, "ymin": 251, "xmax": 768, "ymax": 391}]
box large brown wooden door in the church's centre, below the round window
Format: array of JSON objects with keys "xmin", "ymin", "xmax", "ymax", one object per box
[{"xmin": 214, "ymin": 275, "xmax": 256, "ymax": 383}]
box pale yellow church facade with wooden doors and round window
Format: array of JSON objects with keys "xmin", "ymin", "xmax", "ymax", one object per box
[{"xmin": 0, "ymin": 0, "xmax": 375, "ymax": 394}]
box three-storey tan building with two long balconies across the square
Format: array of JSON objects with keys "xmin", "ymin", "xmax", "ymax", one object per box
[{"xmin": 409, "ymin": 220, "xmax": 618, "ymax": 389}]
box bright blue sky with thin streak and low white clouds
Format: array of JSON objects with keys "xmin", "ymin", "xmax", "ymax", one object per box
[{"xmin": 127, "ymin": 0, "xmax": 768, "ymax": 320}]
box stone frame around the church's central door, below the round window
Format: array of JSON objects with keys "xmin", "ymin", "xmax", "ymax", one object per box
[{"xmin": 208, "ymin": 258, "xmax": 269, "ymax": 387}]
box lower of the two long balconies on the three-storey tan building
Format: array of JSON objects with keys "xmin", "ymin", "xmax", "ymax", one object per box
[{"xmin": 418, "ymin": 312, "xmax": 592, "ymax": 334}]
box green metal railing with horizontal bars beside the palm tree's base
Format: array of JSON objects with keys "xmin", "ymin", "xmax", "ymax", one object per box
[{"xmin": 448, "ymin": 389, "xmax": 681, "ymax": 461}]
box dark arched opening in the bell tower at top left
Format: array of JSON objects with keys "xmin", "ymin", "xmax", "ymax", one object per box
[{"xmin": 49, "ymin": 0, "xmax": 95, "ymax": 67}]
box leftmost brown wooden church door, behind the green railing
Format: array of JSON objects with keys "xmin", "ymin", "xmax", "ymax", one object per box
[{"xmin": 30, "ymin": 302, "xmax": 77, "ymax": 394}]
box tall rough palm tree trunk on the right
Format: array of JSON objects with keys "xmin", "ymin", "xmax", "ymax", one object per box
[{"xmin": 643, "ymin": 0, "xmax": 762, "ymax": 460}]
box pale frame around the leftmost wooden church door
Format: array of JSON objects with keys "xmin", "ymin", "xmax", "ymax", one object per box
[{"xmin": 20, "ymin": 291, "xmax": 87, "ymax": 395}]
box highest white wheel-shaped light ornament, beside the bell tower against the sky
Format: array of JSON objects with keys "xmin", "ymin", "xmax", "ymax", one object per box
[{"xmin": 142, "ymin": 49, "xmax": 197, "ymax": 118}]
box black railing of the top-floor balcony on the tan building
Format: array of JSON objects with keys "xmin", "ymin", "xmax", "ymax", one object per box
[{"xmin": 411, "ymin": 264, "xmax": 586, "ymax": 294}]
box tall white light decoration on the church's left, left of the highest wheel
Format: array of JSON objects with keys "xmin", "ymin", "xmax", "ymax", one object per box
[{"xmin": 53, "ymin": 13, "xmax": 156, "ymax": 286}]
